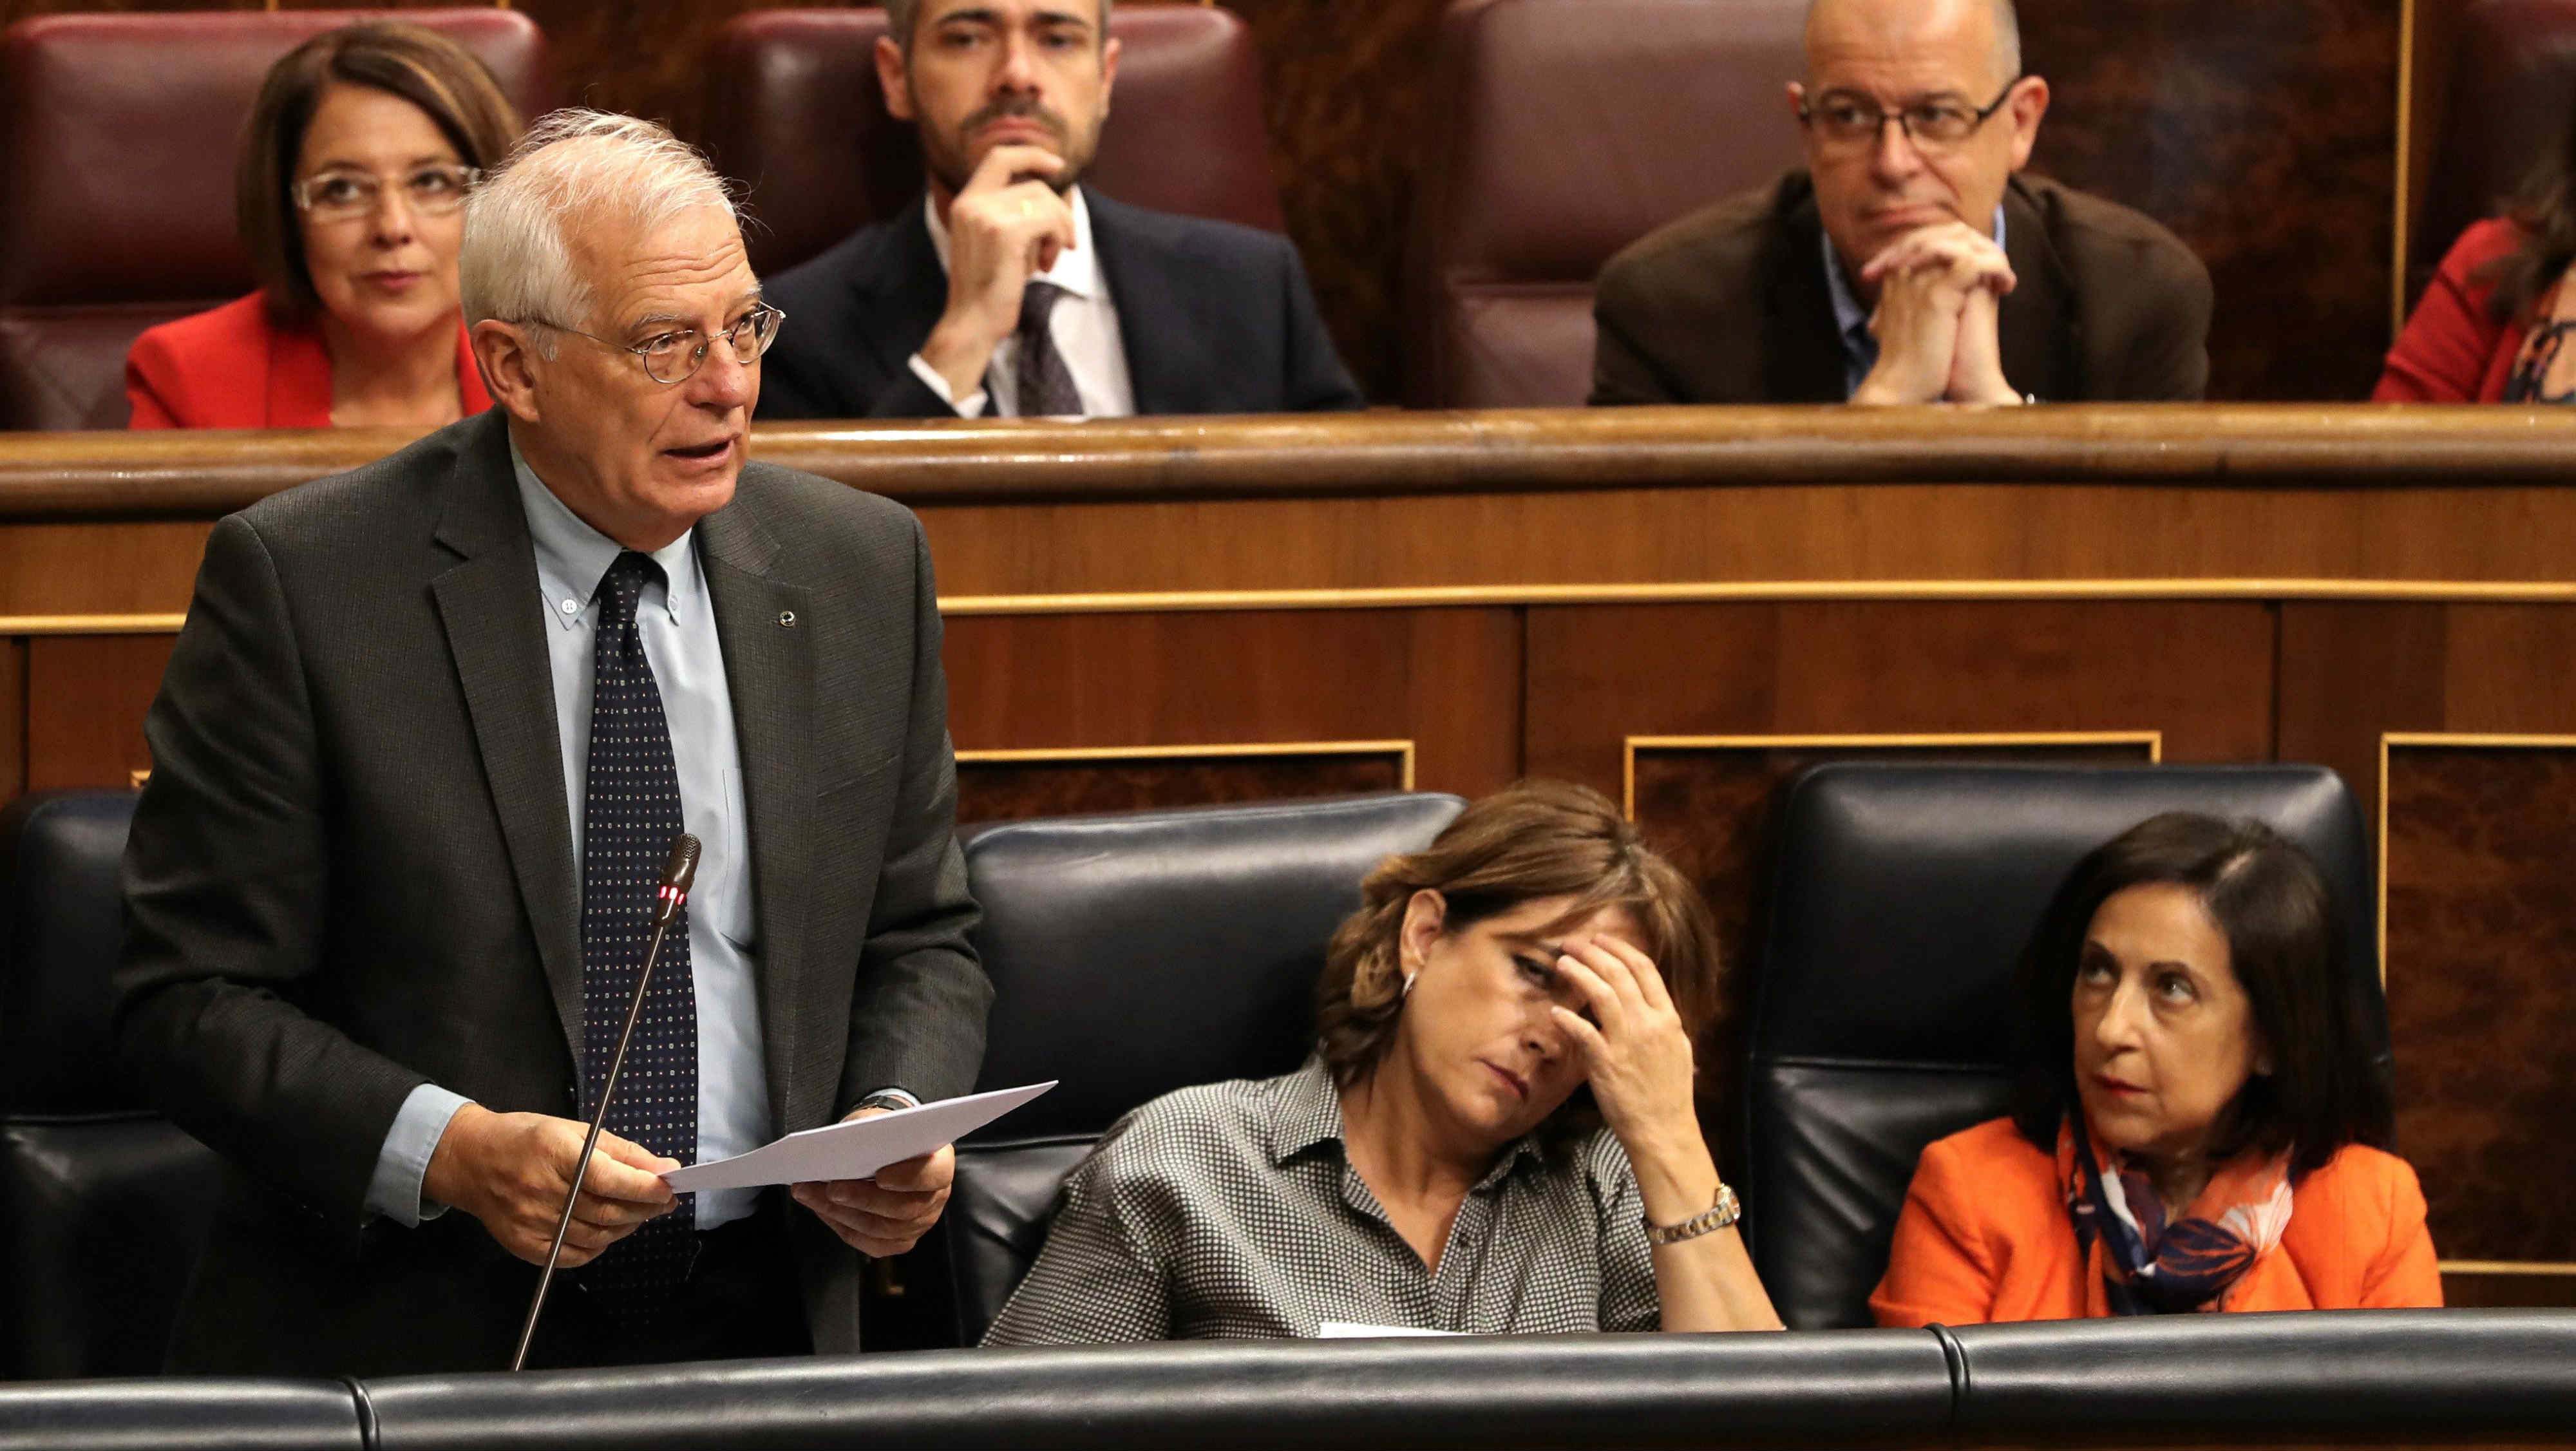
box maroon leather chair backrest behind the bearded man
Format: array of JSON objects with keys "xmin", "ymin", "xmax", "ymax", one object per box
[{"xmin": 706, "ymin": 5, "xmax": 1280, "ymax": 276}]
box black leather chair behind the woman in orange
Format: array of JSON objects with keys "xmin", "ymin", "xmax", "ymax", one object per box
[{"xmin": 1744, "ymin": 763, "xmax": 2388, "ymax": 1330}]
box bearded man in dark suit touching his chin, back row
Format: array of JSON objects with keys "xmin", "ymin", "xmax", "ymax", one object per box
[{"xmin": 760, "ymin": 0, "xmax": 1360, "ymax": 417}]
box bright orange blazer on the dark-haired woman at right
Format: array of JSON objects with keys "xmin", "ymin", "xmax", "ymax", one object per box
[{"xmin": 1870, "ymin": 1119, "xmax": 2442, "ymax": 1325}]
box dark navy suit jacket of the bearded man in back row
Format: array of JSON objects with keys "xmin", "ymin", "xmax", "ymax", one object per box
[{"xmin": 760, "ymin": 188, "xmax": 1360, "ymax": 420}]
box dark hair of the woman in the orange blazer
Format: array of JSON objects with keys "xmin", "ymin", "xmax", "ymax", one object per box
[{"xmin": 2012, "ymin": 812, "xmax": 2393, "ymax": 1173}]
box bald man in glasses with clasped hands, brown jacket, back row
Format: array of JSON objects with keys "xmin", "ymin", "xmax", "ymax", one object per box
[{"xmin": 1592, "ymin": 0, "xmax": 2210, "ymax": 404}]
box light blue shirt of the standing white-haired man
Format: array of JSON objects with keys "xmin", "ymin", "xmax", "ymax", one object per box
[{"xmin": 366, "ymin": 438, "xmax": 770, "ymax": 1229}]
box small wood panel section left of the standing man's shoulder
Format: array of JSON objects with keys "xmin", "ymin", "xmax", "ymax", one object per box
[{"xmin": 26, "ymin": 634, "xmax": 173, "ymax": 792}]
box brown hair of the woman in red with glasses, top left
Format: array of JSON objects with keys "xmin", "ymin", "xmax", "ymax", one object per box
[{"xmin": 232, "ymin": 21, "xmax": 520, "ymax": 322}]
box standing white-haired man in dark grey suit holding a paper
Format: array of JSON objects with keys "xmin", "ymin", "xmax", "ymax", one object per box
[{"xmin": 116, "ymin": 111, "xmax": 992, "ymax": 1376}]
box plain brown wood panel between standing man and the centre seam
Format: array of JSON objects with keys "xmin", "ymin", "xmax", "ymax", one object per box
[{"xmin": 948, "ymin": 611, "xmax": 1520, "ymax": 794}]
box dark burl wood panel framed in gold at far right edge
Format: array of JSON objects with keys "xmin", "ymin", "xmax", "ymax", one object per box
[{"xmin": 2383, "ymin": 737, "xmax": 2576, "ymax": 1267}]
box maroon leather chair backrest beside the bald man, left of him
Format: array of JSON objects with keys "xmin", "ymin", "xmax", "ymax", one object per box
[{"xmin": 1404, "ymin": 0, "xmax": 1806, "ymax": 407}]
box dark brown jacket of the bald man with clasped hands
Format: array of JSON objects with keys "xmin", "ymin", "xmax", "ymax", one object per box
[{"xmin": 1592, "ymin": 170, "xmax": 2210, "ymax": 404}]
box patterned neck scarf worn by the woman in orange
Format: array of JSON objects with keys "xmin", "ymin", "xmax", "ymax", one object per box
[{"xmin": 2058, "ymin": 1114, "xmax": 2290, "ymax": 1314}]
